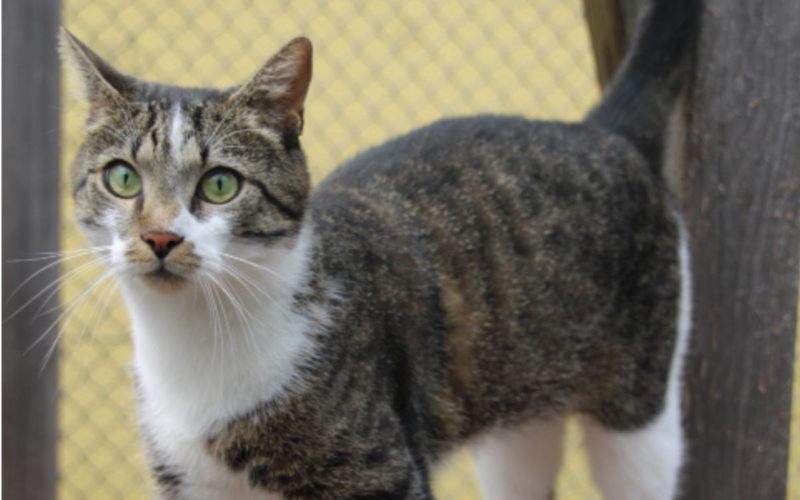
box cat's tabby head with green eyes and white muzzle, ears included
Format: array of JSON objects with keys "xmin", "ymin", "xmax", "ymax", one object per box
[{"xmin": 61, "ymin": 29, "xmax": 311, "ymax": 291}]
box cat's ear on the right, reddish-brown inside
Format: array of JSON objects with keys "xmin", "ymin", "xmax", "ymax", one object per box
[{"xmin": 229, "ymin": 37, "xmax": 312, "ymax": 135}]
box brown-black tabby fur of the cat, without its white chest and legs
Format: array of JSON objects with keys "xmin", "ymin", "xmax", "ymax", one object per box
[{"xmin": 64, "ymin": 0, "xmax": 699, "ymax": 500}]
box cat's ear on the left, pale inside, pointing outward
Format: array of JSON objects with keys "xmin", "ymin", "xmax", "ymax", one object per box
[{"xmin": 59, "ymin": 26, "xmax": 133, "ymax": 121}]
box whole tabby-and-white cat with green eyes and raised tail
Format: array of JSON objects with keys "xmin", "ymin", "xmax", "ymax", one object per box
[{"xmin": 61, "ymin": 0, "xmax": 700, "ymax": 500}]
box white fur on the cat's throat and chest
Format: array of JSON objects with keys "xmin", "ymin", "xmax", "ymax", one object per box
[{"xmin": 123, "ymin": 232, "xmax": 312, "ymax": 500}]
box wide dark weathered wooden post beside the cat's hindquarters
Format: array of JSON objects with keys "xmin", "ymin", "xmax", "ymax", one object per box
[{"xmin": 683, "ymin": 0, "xmax": 800, "ymax": 500}]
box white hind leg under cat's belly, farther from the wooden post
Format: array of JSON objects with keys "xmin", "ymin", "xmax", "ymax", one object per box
[{"xmin": 474, "ymin": 418, "xmax": 564, "ymax": 500}]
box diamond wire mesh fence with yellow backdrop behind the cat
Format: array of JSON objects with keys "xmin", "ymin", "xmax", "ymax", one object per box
[{"xmin": 58, "ymin": 0, "xmax": 599, "ymax": 500}]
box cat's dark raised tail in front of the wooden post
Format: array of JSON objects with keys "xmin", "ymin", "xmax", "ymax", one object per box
[{"xmin": 586, "ymin": 0, "xmax": 702, "ymax": 173}]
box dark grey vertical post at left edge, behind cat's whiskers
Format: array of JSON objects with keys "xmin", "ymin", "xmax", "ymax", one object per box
[{"xmin": 2, "ymin": 0, "xmax": 61, "ymax": 500}]
